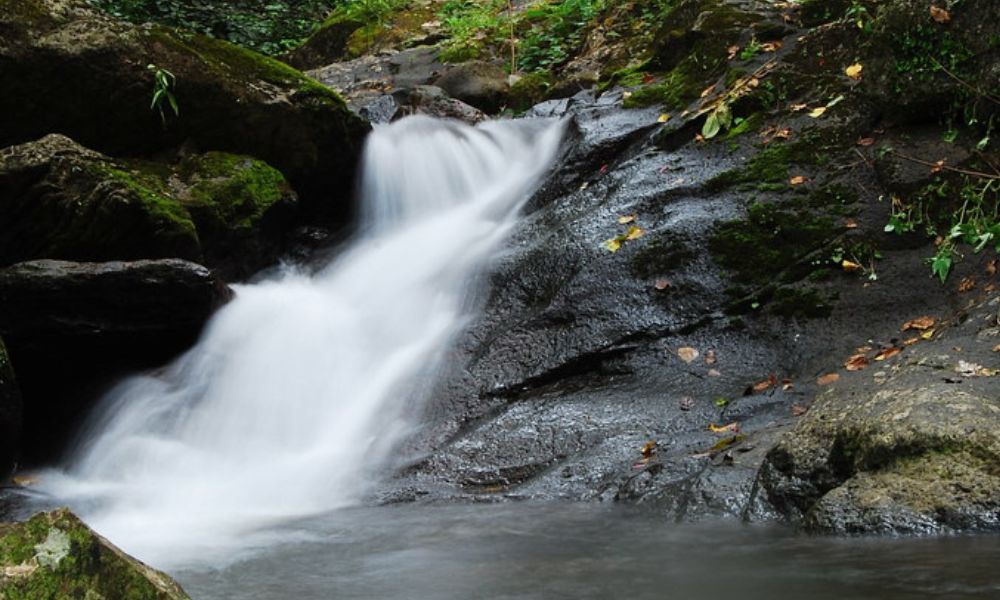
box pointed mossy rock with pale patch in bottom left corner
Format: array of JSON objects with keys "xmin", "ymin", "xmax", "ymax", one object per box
[{"xmin": 0, "ymin": 509, "xmax": 189, "ymax": 600}]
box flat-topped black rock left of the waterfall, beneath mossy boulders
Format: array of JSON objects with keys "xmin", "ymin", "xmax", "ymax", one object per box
[{"xmin": 0, "ymin": 259, "xmax": 231, "ymax": 463}]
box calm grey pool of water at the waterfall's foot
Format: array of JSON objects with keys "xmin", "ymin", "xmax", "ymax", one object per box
[{"xmin": 172, "ymin": 504, "xmax": 1000, "ymax": 600}]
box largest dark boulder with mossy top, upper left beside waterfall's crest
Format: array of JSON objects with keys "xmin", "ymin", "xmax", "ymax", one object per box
[{"xmin": 0, "ymin": 0, "xmax": 368, "ymax": 219}]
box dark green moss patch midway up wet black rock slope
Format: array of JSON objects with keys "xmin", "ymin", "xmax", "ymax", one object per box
[{"xmin": 709, "ymin": 203, "xmax": 840, "ymax": 286}]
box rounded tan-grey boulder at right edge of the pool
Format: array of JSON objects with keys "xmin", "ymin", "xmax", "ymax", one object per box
[{"xmin": 761, "ymin": 383, "xmax": 1000, "ymax": 533}]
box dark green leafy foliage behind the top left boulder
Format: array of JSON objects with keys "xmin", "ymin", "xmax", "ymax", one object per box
[{"xmin": 87, "ymin": 0, "xmax": 340, "ymax": 55}]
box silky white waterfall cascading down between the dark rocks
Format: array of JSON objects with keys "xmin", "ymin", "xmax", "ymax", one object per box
[{"xmin": 40, "ymin": 117, "xmax": 562, "ymax": 567}]
